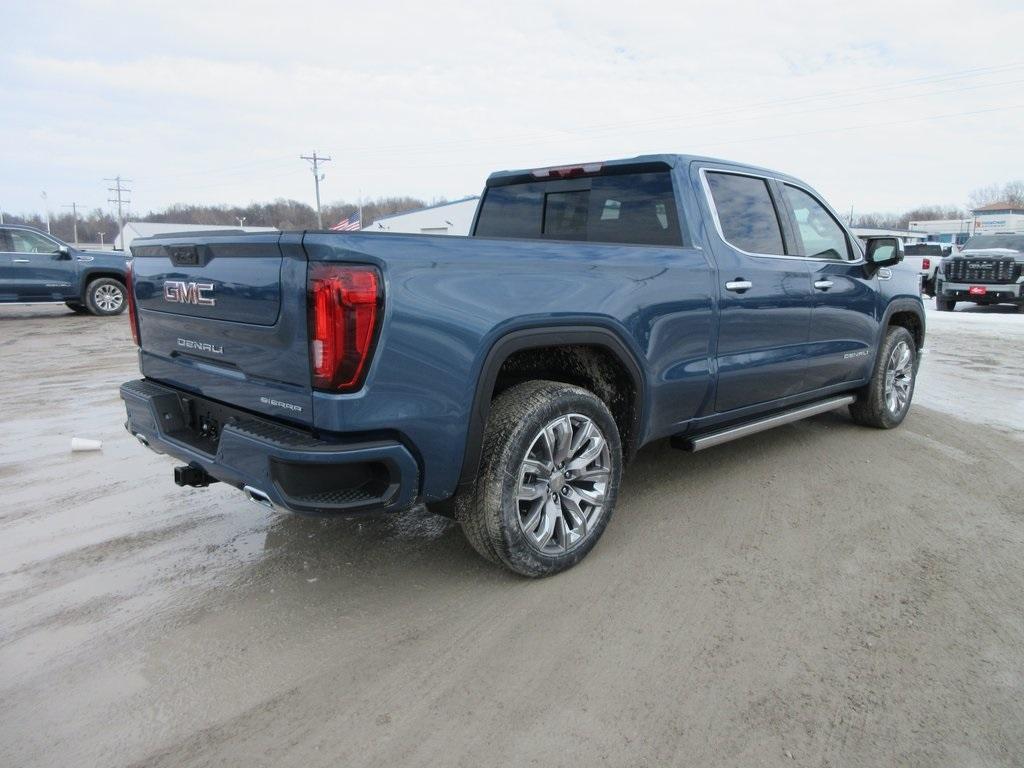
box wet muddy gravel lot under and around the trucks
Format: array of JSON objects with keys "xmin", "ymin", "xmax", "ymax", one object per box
[{"xmin": 0, "ymin": 306, "xmax": 1024, "ymax": 768}]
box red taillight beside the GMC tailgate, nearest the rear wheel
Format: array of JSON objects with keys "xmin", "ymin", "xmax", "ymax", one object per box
[{"xmin": 308, "ymin": 264, "xmax": 381, "ymax": 391}]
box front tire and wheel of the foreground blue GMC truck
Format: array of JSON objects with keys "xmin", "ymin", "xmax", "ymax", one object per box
[{"xmin": 850, "ymin": 326, "xmax": 919, "ymax": 429}]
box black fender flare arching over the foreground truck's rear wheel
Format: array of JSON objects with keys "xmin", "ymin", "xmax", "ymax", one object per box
[{"xmin": 459, "ymin": 325, "xmax": 645, "ymax": 490}]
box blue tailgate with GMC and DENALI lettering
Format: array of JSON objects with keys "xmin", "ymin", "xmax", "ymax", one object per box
[{"xmin": 132, "ymin": 232, "xmax": 312, "ymax": 424}]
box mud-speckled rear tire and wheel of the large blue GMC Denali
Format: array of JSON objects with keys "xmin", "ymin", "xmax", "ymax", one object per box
[{"xmin": 457, "ymin": 381, "xmax": 623, "ymax": 577}]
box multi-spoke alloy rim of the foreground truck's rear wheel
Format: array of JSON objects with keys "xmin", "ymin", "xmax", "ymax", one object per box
[{"xmin": 516, "ymin": 414, "xmax": 611, "ymax": 555}]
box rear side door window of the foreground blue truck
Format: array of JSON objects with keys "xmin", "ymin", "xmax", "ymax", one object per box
[{"xmin": 706, "ymin": 172, "xmax": 785, "ymax": 256}]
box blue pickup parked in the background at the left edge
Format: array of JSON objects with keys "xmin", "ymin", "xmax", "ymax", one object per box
[{"xmin": 0, "ymin": 224, "xmax": 128, "ymax": 315}]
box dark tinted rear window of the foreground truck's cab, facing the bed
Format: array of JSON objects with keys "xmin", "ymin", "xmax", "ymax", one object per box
[{"xmin": 474, "ymin": 171, "xmax": 682, "ymax": 246}]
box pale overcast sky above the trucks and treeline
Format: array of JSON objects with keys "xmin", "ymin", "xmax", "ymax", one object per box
[{"xmin": 0, "ymin": 0, "xmax": 1024, "ymax": 219}]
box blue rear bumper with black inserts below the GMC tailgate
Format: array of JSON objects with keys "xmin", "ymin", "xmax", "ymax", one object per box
[{"xmin": 121, "ymin": 379, "xmax": 420, "ymax": 515}]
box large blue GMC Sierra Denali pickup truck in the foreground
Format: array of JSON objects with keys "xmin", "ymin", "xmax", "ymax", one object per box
[{"xmin": 121, "ymin": 155, "xmax": 925, "ymax": 575}]
